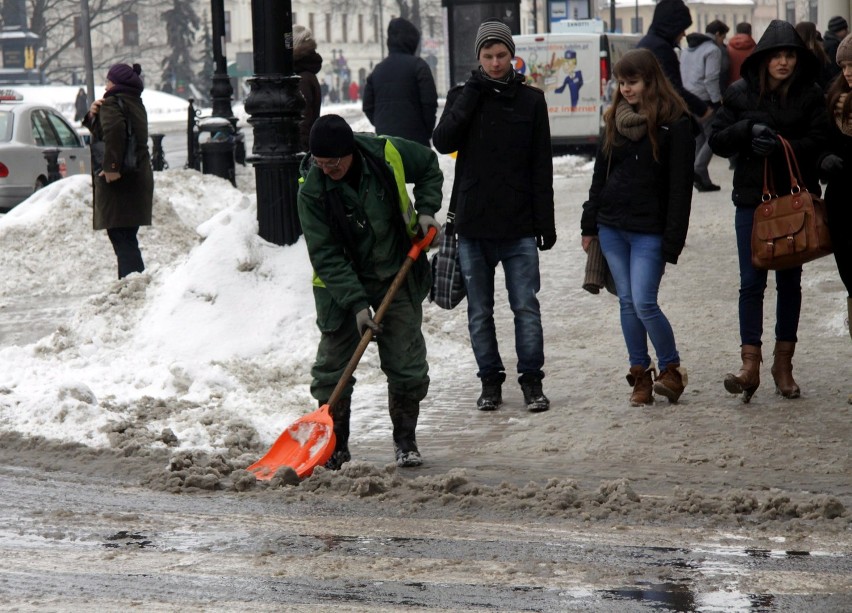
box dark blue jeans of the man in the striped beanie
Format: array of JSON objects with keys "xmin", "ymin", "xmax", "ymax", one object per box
[{"xmin": 459, "ymin": 236, "xmax": 544, "ymax": 379}]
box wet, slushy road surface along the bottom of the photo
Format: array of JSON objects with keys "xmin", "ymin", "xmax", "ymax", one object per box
[{"xmin": 0, "ymin": 464, "xmax": 852, "ymax": 612}]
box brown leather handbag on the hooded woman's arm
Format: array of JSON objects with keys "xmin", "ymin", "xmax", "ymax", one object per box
[{"xmin": 751, "ymin": 136, "xmax": 832, "ymax": 270}]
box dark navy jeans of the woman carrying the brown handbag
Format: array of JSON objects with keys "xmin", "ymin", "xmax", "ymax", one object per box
[{"xmin": 734, "ymin": 207, "xmax": 802, "ymax": 347}]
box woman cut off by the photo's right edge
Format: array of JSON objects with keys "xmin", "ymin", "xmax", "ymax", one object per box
[{"xmin": 820, "ymin": 35, "xmax": 852, "ymax": 402}]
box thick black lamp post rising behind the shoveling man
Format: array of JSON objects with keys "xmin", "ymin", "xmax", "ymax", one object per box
[{"xmin": 245, "ymin": 0, "xmax": 305, "ymax": 245}]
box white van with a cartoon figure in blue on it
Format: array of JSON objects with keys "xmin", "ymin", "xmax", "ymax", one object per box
[{"xmin": 512, "ymin": 32, "xmax": 641, "ymax": 149}]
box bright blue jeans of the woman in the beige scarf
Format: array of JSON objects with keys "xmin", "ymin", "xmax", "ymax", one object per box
[{"xmin": 598, "ymin": 225, "xmax": 680, "ymax": 371}]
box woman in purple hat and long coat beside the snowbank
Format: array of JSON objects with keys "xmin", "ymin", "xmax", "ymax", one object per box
[{"xmin": 83, "ymin": 64, "xmax": 154, "ymax": 279}]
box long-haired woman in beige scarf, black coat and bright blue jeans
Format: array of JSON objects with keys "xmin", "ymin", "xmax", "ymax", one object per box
[{"xmin": 580, "ymin": 49, "xmax": 696, "ymax": 406}]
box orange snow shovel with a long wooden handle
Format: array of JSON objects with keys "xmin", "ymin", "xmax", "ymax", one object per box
[{"xmin": 247, "ymin": 228, "xmax": 437, "ymax": 480}]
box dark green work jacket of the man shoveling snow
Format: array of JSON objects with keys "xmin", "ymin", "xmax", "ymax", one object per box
[{"xmin": 298, "ymin": 134, "xmax": 444, "ymax": 332}]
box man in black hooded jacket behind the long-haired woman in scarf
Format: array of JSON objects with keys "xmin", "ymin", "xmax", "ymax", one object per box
[{"xmin": 636, "ymin": 0, "xmax": 713, "ymax": 119}]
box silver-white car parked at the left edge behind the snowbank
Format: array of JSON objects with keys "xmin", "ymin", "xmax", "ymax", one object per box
[{"xmin": 0, "ymin": 90, "xmax": 91, "ymax": 211}]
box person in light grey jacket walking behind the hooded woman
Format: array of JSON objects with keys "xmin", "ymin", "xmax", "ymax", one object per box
[{"xmin": 680, "ymin": 21, "xmax": 728, "ymax": 192}]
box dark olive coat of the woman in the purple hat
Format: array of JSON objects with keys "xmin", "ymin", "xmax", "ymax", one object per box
[{"xmin": 83, "ymin": 94, "xmax": 154, "ymax": 230}]
